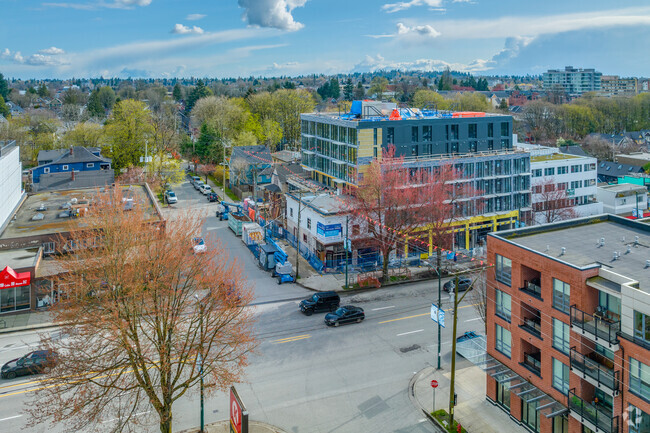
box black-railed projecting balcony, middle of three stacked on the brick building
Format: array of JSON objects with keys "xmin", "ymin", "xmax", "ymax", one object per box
[{"xmin": 570, "ymin": 347, "xmax": 621, "ymax": 397}]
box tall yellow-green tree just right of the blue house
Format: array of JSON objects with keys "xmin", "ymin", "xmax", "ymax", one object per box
[{"xmin": 106, "ymin": 99, "xmax": 153, "ymax": 171}]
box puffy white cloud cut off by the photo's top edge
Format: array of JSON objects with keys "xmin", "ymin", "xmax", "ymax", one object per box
[{"xmin": 239, "ymin": 0, "xmax": 307, "ymax": 31}]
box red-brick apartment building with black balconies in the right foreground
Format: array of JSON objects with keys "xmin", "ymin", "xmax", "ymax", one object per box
[{"xmin": 486, "ymin": 215, "xmax": 650, "ymax": 433}]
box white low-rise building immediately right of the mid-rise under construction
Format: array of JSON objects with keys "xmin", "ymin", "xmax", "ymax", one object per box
[{"xmin": 517, "ymin": 143, "xmax": 603, "ymax": 224}]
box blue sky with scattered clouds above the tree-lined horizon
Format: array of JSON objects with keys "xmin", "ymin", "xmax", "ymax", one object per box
[{"xmin": 0, "ymin": 0, "xmax": 650, "ymax": 78}]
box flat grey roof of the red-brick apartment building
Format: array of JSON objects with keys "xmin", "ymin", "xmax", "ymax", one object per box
[{"xmin": 488, "ymin": 215, "xmax": 650, "ymax": 292}]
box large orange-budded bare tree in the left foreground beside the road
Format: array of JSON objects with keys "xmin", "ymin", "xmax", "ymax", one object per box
[{"xmin": 26, "ymin": 186, "xmax": 255, "ymax": 433}]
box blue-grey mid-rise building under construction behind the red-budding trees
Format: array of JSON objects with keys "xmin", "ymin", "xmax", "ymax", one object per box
[{"xmin": 301, "ymin": 101, "xmax": 531, "ymax": 249}]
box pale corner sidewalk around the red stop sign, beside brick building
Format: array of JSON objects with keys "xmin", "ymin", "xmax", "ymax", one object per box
[{"xmin": 409, "ymin": 366, "xmax": 527, "ymax": 433}]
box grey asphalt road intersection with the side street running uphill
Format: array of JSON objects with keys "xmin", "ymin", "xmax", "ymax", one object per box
[{"xmin": 0, "ymin": 176, "xmax": 483, "ymax": 433}]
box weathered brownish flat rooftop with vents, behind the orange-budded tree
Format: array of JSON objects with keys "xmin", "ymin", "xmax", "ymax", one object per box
[{"xmin": 0, "ymin": 185, "xmax": 156, "ymax": 240}]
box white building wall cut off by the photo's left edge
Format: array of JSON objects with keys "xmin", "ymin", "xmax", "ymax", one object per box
[{"xmin": 0, "ymin": 141, "xmax": 25, "ymax": 232}]
